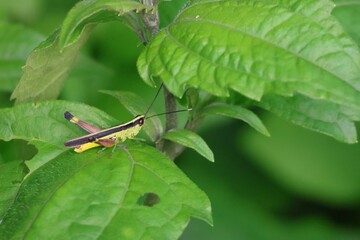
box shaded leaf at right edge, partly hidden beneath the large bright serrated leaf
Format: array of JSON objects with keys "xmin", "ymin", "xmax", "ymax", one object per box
[{"xmin": 258, "ymin": 94, "xmax": 357, "ymax": 143}]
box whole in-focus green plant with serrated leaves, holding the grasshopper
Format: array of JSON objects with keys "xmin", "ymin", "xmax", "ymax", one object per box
[{"xmin": 0, "ymin": 0, "xmax": 360, "ymax": 239}]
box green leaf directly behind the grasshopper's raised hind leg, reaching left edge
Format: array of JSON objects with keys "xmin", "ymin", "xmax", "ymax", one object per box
[{"xmin": 0, "ymin": 101, "xmax": 118, "ymax": 146}]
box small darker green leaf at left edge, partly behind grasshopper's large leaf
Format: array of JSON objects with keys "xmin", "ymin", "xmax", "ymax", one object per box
[{"xmin": 0, "ymin": 160, "xmax": 27, "ymax": 219}]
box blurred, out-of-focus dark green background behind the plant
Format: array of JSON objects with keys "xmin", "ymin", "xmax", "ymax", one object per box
[{"xmin": 0, "ymin": 0, "xmax": 360, "ymax": 240}]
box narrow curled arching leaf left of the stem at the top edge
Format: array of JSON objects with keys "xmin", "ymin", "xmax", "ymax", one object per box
[{"xmin": 60, "ymin": 0, "xmax": 153, "ymax": 49}]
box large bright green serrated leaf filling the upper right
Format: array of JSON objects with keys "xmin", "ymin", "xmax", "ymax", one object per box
[{"xmin": 138, "ymin": 0, "xmax": 360, "ymax": 122}]
